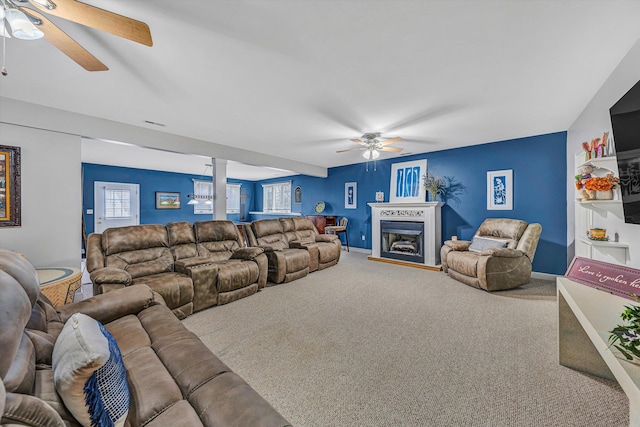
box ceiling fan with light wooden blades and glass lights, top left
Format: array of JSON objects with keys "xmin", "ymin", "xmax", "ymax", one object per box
[{"xmin": 0, "ymin": 0, "xmax": 153, "ymax": 75}]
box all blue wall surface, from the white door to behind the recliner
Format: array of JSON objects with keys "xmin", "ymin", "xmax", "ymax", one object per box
[{"xmin": 83, "ymin": 132, "xmax": 567, "ymax": 274}]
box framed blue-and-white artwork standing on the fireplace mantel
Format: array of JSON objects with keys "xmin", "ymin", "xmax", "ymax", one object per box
[{"xmin": 389, "ymin": 159, "xmax": 427, "ymax": 203}]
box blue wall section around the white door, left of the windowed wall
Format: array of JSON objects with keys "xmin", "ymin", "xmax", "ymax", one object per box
[{"xmin": 82, "ymin": 163, "xmax": 254, "ymax": 235}]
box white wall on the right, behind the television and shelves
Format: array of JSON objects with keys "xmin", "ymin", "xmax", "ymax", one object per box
[{"xmin": 567, "ymin": 40, "xmax": 640, "ymax": 268}]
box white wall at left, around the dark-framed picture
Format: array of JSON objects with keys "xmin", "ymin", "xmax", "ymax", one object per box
[{"xmin": 0, "ymin": 123, "xmax": 82, "ymax": 268}]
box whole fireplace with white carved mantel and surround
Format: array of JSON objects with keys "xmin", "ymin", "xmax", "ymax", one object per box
[{"xmin": 368, "ymin": 202, "xmax": 443, "ymax": 270}]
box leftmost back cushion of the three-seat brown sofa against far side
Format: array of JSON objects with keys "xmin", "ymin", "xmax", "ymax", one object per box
[{"xmin": 102, "ymin": 224, "xmax": 173, "ymax": 279}]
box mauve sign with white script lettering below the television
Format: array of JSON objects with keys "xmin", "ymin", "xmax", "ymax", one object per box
[{"xmin": 564, "ymin": 257, "xmax": 640, "ymax": 300}]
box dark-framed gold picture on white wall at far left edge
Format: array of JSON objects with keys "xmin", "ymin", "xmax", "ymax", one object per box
[{"xmin": 0, "ymin": 145, "xmax": 21, "ymax": 227}]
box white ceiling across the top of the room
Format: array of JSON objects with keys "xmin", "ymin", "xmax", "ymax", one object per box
[{"xmin": 0, "ymin": 0, "xmax": 640, "ymax": 179}]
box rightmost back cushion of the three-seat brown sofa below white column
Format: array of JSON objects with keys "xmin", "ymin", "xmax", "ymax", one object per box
[{"xmin": 193, "ymin": 220, "xmax": 242, "ymax": 261}]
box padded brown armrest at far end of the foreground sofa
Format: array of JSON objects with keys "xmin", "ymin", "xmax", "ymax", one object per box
[{"xmin": 56, "ymin": 285, "xmax": 161, "ymax": 324}]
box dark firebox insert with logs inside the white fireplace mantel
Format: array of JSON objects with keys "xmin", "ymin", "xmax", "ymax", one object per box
[{"xmin": 380, "ymin": 221, "xmax": 424, "ymax": 264}]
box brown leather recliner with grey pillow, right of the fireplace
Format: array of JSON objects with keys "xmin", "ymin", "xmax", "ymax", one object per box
[{"xmin": 440, "ymin": 218, "xmax": 542, "ymax": 291}]
